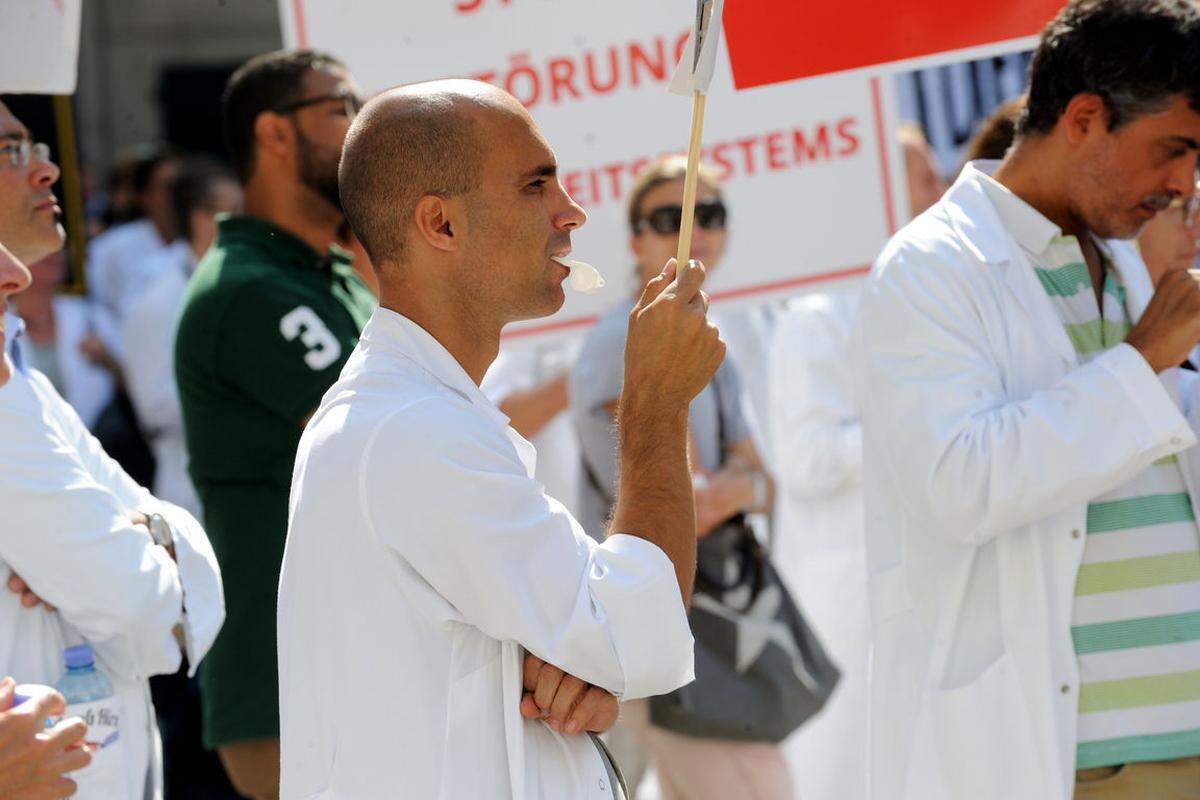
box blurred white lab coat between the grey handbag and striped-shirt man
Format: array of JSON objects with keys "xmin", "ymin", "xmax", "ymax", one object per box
[{"xmin": 770, "ymin": 289, "xmax": 869, "ymax": 800}]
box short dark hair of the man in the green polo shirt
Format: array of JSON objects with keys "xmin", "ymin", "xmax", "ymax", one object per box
[{"xmin": 221, "ymin": 50, "xmax": 346, "ymax": 182}]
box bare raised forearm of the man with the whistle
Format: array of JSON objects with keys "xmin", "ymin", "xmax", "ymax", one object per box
[{"xmin": 612, "ymin": 398, "xmax": 696, "ymax": 604}]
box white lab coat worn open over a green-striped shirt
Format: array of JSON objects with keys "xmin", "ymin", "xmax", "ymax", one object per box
[{"xmin": 854, "ymin": 166, "xmax": 1200, "ymax": 800}]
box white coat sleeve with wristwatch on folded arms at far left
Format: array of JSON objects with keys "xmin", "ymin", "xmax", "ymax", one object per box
[{"xmin": 0, "ymin": 374, "xmax": 224, "ymax": 675}]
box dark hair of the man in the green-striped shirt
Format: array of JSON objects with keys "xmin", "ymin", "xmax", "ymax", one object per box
[{"xmin": 1016, "ymin": 0, "xmax": 1200, "ymax": 136}]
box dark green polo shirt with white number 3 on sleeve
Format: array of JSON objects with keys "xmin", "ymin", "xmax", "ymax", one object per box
[{"xmin": 175, "ymin": 216, "xmax": 376, "ymax": 747}]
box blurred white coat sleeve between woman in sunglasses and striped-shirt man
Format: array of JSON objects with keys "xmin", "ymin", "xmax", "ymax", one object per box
[{"xmin": 770, "ymin": 306, "xmax": 863, "ymax": 500}]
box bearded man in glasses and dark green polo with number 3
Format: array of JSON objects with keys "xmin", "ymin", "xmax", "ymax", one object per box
[{"xmin": 175, "ymin": 50, "xmax": 374, "ymax": 800}]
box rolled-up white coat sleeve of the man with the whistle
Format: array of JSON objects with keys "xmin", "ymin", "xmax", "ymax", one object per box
[{"xmin": 361, "ymin": 399, "xmax": 694, "ymax": 699}]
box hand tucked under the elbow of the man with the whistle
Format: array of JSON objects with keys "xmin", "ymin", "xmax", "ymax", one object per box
[{"xmin": 521, "ymin": 652, "xmax": 619, "ymax": 734}]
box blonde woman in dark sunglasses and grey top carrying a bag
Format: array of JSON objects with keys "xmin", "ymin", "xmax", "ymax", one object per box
[{"xmin": 570, "ymin": 157, "xmax": 792, "ymax": 800}]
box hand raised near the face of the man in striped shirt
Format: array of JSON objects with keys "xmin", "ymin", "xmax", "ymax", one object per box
[{"xmin": 1126, "ymin": 271, "xmax": 1200, "ymax": 372}]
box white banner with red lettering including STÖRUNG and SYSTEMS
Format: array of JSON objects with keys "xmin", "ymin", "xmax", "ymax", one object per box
[{"xmin": 280, "ymin": 0, "xmax": 1052, "ymax": 342}]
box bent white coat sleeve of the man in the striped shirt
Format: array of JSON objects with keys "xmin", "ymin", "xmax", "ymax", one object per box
[{"xmin": 854, "ymin": 247, "xmax": 1195, "ymax": 545}]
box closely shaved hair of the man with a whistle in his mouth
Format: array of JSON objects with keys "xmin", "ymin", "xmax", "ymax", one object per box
[{"xmin": 338, "ymin": 80, "xmax": 526, "ymax": 267}]
